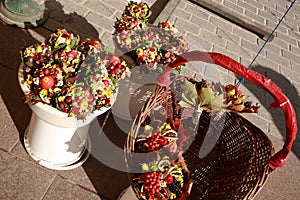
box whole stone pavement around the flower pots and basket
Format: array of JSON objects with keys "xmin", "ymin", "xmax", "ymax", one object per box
[{"xmin": 0, "ymin": 0, "xmax": 300, "ymax": 200}]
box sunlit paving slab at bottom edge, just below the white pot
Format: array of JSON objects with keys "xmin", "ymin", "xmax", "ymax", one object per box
[{"xmin": 43, "ymin": 176, "xmax": 101, "ymax": 200}]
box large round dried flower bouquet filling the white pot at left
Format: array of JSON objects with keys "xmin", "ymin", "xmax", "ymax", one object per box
[{"xmin": 21, "ymin": 29, "xmax": 129, "ymax": 119}]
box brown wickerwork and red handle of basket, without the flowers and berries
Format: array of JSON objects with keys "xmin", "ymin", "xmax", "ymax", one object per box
[{"xmin": 125, "ymin": 51, "xmax": 297, "ymax": 200}]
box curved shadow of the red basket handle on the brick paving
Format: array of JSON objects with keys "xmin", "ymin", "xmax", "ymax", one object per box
[{"xmin": 238, "ymin": 65, "xmax": 300, "ymax": 159}]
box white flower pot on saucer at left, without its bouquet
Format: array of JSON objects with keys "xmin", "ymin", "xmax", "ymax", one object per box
[{"xmin": 18, "ymin": 65, "xmax": 116, "ymax": 170}]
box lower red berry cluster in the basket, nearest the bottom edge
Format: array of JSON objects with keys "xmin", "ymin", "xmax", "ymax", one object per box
[{"xmin": 141, "ymin": 171, "xmax": 162, "ymax": 199}]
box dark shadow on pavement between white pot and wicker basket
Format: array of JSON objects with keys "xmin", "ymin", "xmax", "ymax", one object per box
[{"xmin": 83, "ymin": 113, "xmax": 131, "ymax": 199}]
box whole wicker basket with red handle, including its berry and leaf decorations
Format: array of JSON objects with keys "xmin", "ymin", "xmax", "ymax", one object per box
[{"xmin": 125, "ymin": 51, "xmax": 297, "ymax": 200}]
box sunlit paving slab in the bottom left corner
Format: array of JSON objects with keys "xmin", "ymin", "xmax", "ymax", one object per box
[{"xmin": 0, "ymin": 150, "xmax": 54, "ymax": 200}]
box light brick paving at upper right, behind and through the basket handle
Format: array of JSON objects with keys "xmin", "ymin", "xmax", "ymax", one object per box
[{"xmin": 170, "ymin": 0, "xmax": 300, "ymax": 145}]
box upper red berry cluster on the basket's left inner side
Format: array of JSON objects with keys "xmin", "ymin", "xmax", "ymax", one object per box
[{"xmin": 144, "ymin": 132, "xmax": 169, "ymax": 152}]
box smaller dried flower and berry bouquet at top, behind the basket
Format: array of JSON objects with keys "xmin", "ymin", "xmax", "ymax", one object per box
[{"xmin": 113, "ymin": 1, "xmax": 188, "ymax": 72}]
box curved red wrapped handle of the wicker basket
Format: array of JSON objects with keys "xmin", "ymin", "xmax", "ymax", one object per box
[{"xmin": 158, "ymin": 51, "xmax": 298, "ymax": 169}]
